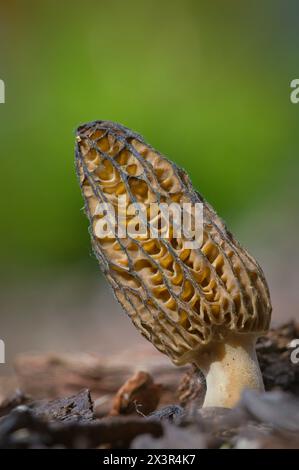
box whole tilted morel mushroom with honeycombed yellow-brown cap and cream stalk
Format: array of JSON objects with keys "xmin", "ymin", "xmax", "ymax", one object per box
[{"xmin": 76, "ymin": 121, "xmax": 271, "ymax": 407}]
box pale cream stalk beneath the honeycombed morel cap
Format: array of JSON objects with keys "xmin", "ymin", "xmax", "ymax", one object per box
[{"xmin": 194, "ymin": 334, "xmax": 264, "ymax": 408}]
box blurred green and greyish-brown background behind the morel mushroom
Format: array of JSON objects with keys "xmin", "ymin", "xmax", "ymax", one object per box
[{"xmin": 0, "ymin": 0, "xmax": 299, "ymax": 373}]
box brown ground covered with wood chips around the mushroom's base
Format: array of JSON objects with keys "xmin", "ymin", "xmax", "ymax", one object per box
[{"xmin": 0, "ymin": 322, "xmax": 299, "ymax": 449}]
